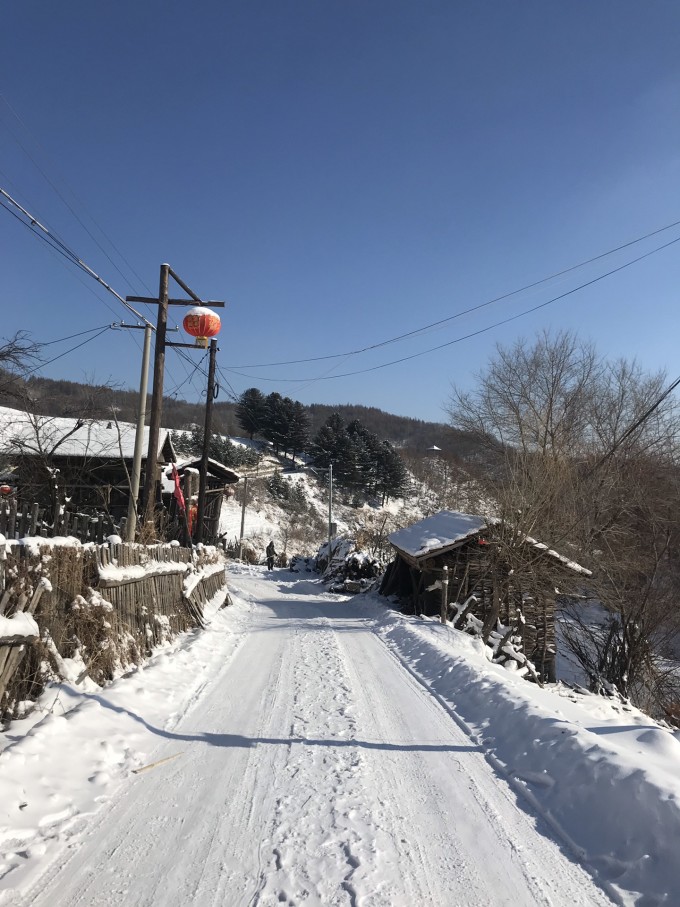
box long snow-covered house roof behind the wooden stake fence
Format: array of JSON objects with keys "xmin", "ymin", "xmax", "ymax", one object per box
[{"xmin": 0, "ymin": 406, "xmax": 173, "ymax": 459}]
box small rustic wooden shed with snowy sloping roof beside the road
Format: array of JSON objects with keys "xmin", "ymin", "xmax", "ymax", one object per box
[{"xmin": 380, "ymin": 510, "xmax": 590, "ymax": 681}]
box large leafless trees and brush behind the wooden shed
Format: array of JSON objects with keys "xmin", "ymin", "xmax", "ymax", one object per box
[{"xmin": 448, "ymin": 333, "xmax": 680, "ymax": 711}]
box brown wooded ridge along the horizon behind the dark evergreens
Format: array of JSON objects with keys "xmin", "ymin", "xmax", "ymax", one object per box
[{"xmin": 0, "ymin": 374, "xmax": 476, "ymax": 458}]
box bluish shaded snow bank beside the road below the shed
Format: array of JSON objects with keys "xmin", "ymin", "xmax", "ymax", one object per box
[{"xmin": 380, "ymin": 600, "xmax": 680, "ymax": 905}]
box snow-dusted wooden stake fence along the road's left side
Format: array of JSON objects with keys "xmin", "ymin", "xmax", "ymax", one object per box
[{"xmin": 0, "ymin": 540, "xmax": 227, "ymax": 719}]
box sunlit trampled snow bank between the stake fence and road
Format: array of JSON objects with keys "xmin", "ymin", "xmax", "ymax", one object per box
[{"xmin": 0, "ymin": 594, "xmax": 248, "ymax": 892}]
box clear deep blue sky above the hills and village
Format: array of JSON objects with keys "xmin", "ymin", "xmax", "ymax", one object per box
[{"xmin": 0, "ymin": 0, "xmax": 680, "ymax": 421}]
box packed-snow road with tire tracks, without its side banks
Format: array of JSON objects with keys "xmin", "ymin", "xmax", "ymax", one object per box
[{"xmin": 17, "ymin": 568, "xmax": 611, "ymax": 907}]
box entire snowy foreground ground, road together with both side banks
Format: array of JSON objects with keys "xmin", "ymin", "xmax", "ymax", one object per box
[{"xmin": 0, "ymin": 566, "xmax": 680, "ymax": 907}]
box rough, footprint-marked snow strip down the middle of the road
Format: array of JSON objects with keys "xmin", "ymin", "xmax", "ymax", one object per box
[{"xmin": 252, "ymin": 617, "xmax": 391, "ymax": 907}]
